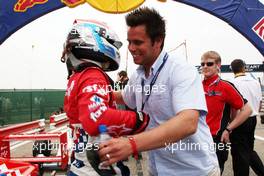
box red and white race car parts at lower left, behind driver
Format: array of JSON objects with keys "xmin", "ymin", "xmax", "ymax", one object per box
[{"xmin": 0, "ymin": 117, "xmax": 71, "ymax": 176}]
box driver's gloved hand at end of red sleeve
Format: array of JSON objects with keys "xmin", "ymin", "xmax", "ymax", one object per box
[{"xmin": 132, "ymin": 111, "xmax": 149, "ymax": 134}]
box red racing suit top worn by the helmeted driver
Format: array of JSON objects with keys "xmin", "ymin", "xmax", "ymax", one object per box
[{"xmin": 64, "ymin": 67, "xmax": 136, "ymax": 136}]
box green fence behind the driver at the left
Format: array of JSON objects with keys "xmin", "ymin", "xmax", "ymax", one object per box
[{"xmin": 0, "ymin": 89, "xmax": 65, "ymax": 125}]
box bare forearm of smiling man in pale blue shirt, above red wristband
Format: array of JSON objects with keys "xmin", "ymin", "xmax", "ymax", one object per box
[{"xmin": 134, "ymin": 110, "xmax": 199, "ymax": 151}]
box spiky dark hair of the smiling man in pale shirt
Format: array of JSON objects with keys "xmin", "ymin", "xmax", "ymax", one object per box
[{"xmin": 126, "ymin": 7, "xmax": 166, "ymax": 49}]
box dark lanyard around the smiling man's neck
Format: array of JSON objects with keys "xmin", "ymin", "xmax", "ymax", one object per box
[{"xmin": 141, "ymin": 53, "xmax": 169, "ymax": 111}]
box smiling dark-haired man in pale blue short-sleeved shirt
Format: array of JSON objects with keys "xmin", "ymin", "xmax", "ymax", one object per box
[{"xmin": 99, "ymin": 7, "xmax": 220, "ymax": 176}]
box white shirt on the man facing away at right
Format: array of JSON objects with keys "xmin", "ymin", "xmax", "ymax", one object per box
[{"xmin": 231, "ymin": 75, "xmax": 262, "ymax": 116}]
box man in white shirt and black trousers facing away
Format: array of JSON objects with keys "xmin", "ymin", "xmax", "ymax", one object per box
[{"xmin": 231, "ymin": 59, "xmax": 264, "ymax": 176}]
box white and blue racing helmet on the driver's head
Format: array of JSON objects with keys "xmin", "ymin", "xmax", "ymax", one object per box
[{"xmin": 61, "ymin": 20, "xmax": 122, "ymax": 74}]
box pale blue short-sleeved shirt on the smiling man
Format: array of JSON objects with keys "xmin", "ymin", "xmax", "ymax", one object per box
[{"xmin": 122, "ymin": 52, "xmax": 218, "ymax": 176}]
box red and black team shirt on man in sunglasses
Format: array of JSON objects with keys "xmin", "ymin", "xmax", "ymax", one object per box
[{"xmin": 203, "ymin": 75, "xmax": 247, "ymax": 137}]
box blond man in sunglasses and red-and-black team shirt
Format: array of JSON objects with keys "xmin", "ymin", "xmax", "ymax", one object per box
[{"xmin": 201, "ymin": 51, "xmax": 252, "ymax": 173}]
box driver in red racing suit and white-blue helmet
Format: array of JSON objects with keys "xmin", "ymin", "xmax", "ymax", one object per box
[{"xmin": 61, "ymin": 20, "xmax": 149, "ymax": 176}]
